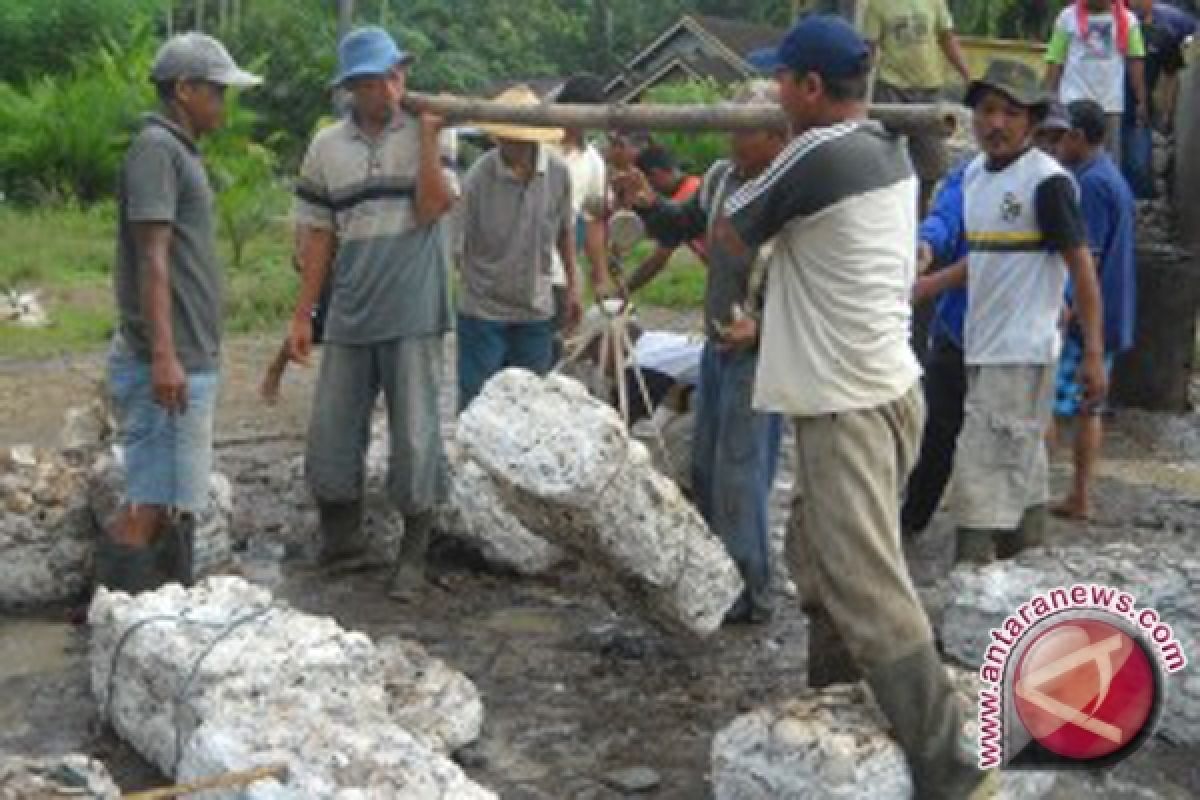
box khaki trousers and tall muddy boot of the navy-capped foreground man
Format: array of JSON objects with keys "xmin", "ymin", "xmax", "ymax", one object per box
[{"xmin": 787, "ymin": 386, "xmax": 978, "ymax": 798}]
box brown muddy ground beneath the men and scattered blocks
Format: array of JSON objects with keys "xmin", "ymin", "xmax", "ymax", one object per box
[{"xmin": 0, "ymin": 326, "xmax": 1200, "ymax": 800}]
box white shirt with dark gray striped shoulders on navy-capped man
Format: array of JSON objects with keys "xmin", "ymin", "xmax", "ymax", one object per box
[{"xmin": 725, "ymin": 120, "xmax": 920, "ymax": 416}]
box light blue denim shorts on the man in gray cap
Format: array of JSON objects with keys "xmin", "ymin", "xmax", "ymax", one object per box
[{"xmin": 108, "ymin": 333, "xmax": 220, "ymax": 513}]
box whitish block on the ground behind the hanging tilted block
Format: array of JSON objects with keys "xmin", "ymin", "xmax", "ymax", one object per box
[{"xmin": 438, "ymin": 447, "xmax": 565, "ymax": 576}]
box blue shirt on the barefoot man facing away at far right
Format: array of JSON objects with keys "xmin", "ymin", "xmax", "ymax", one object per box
[{"xmin": 1068, "ymin": 152, "xmax": 1138, "ymax": 354}]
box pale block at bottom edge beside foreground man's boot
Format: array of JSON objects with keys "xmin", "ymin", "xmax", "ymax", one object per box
[{"xmin": 712, "ymin": 672, "xmax": 1070, "ymax": 800}]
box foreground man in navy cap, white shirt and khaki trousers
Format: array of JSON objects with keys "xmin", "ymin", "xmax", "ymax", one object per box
[{"xmin": 725, "ymin": 16, "xmax": 985, "ymax": 800}]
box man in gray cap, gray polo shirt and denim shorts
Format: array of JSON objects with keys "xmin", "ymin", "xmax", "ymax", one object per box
[{"xmin": 96, "ymin": 34, "xmax": 262, "ymax": 591}]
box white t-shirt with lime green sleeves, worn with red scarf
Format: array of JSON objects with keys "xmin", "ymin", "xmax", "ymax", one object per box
[{"xmin": 1046, "ymin": 5, "xmax": 1146, "ymax": 114}]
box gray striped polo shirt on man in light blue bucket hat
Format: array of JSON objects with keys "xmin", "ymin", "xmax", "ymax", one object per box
[{"xmin": 295, "ymin": 112, "xmax": 457, "ymax": 344}]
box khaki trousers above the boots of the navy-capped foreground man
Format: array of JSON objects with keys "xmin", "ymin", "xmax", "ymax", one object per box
[{"xmin": 787, "ymin": 385, "xmax": 934, "ymax": 673}]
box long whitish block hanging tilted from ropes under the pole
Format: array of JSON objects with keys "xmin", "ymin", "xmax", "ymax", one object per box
[{"xmin": 458, "ymin": 369, "xmax": 742, "ymax": 634}]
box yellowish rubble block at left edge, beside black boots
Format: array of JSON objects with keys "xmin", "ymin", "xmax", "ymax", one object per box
[{"xmin": 0, "ymin": 447, "xmax": 95, "ymax": 608}]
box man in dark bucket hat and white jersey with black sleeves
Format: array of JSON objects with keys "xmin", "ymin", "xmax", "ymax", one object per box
[{"xmin": 916, "ymin": 60, "xmax": 1108, "ymax": 564}]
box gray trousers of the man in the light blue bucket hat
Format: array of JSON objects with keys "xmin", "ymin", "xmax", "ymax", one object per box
[{"xmin": 305, "ymin": 335, "xmax": 448, "ymax": 515}]
